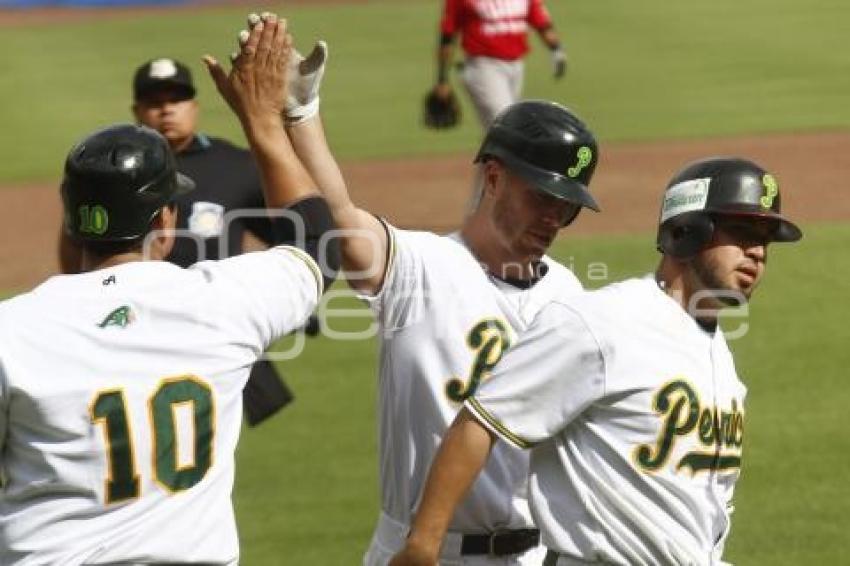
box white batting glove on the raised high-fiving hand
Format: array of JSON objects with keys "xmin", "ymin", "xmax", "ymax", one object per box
[{"xmin": 283, "ymin": 41, "xmax": 328, "ymax": 126}]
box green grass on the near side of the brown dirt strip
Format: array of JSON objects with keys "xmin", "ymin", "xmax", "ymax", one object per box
[{"xmin": 236, "ymin": 225, "xmax": 850, "ymax": 566}]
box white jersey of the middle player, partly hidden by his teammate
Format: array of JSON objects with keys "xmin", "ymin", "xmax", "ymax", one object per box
[{"xmin": 360, "ymin": 228, "xmax": 581, "ymax": 552}]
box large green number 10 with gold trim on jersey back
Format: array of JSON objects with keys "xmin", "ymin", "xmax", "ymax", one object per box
[{"xmin": 91, "ymin": 376, "xmax": 215, "ymax": 503}]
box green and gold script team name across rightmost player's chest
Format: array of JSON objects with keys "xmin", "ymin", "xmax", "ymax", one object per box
[{"xmin": 633, "ymin": 377, "xmax": 744, "ymax": 474}]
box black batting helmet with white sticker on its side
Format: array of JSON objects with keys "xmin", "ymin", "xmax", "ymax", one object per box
[{"xmin": 657, "ymin": 157, "xmax": 803, "ymax": 258}]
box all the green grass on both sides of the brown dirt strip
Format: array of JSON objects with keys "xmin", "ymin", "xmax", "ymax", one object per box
[{"xmin": 0, "ymin": 0, "xmax": 850, "ymax": 566}]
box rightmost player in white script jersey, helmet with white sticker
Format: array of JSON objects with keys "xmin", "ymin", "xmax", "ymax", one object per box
[{"xmin": 392, "ymin": 158, "xmax": 802, "ymax": 566}]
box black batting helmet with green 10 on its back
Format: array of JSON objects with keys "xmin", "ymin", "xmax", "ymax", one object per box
[{"xmin": 61, "ymin": 124, "xmax": 195, "ymax": 242}]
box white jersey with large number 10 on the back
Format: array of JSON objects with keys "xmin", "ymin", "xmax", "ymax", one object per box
[{"xmin": 0, "ymin": 247, "xmax": 322, "ymax": 566}]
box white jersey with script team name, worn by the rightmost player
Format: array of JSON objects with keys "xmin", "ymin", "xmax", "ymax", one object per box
[{"xmin": 466, "ymin": 277, "xmax": 746, "ymax": 565}]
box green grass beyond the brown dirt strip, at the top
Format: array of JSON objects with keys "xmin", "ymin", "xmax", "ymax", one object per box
[{"xmin": 0, "ymin": 0, "xmax": 850, "ymax": 184}]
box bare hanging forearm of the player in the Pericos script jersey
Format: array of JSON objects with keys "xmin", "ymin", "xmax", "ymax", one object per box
[{"xmin": 407, "ymin": 409, "xmax": 495, "ymax": 558}]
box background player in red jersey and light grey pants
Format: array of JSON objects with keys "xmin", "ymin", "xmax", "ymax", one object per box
[{"xmin": 434, "ymin": 0, "xmax": 567, "ymax": 130}]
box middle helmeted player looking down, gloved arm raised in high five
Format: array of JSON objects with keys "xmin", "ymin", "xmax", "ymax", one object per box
[{"xmin": 262, "ymin": 23, "xmax": 598, "ymax": 566}]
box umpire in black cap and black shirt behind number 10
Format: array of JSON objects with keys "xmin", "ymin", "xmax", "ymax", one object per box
[{"xmin": 59, "ymin": 58, "xmax": 318, "ymax": 426}]
